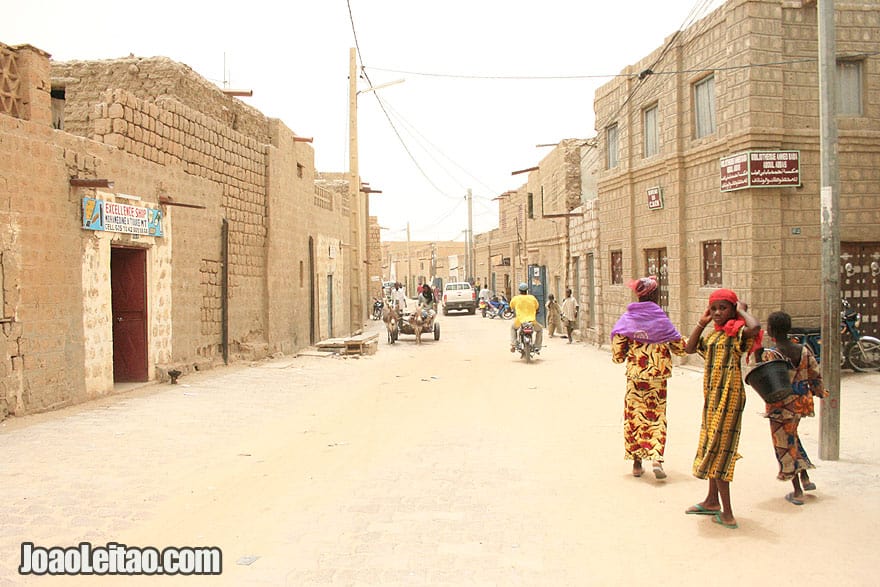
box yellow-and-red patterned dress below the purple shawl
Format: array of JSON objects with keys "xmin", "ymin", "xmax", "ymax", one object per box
[{"xmin": 611, "ymin": 334, "xmax": 685, "ymax": 462}]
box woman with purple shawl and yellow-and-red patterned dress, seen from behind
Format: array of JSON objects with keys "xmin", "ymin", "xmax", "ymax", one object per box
[{"xmin": 611, "ymin": 276, "xmax": 685, "ymax": 479}]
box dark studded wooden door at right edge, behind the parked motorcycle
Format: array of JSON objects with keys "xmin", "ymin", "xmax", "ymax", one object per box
[{"xmin": 840, "ymin": 243, "xmax": 880, "ymax": 336}]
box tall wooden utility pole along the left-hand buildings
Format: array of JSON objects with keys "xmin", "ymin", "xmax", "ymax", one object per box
[{"xmin": 348, "ymin": 47, "xmax": 366, "ymax": 334}]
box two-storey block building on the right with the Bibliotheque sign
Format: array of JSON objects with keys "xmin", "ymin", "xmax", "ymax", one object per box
[{"xmin": 595, "ymin": 0, "xmax": 880, "ymax": 334}]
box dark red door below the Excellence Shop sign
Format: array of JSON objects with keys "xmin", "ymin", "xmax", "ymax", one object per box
[{"xmin": 110, "ymin": 248, "xmax": 149, "ymax": 381}]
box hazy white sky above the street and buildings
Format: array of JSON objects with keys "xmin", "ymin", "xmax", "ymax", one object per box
[{"xmin": 6, "ymin": 0, "xmax": 721, "ymax": 240}]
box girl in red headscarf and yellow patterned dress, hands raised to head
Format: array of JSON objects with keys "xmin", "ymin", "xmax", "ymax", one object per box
[{"xmin": 685, "ymin": 289, "xmax": 761, "ymax": 529}]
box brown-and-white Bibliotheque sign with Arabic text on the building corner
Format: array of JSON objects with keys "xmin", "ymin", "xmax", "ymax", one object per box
[{"xmin": 721, "ymin": 151, "xmax": 801, "ymax": 192}]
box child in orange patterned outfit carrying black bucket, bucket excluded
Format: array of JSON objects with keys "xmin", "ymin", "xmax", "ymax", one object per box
[{"xmin": 761, "ymin": 312, "xmax": 828, "ymax": 505}]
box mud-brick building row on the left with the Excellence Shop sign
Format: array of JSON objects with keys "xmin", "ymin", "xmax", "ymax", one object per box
[{"xmin": 0, "ymin": 44, "xmax": 350, "ymax": 418}]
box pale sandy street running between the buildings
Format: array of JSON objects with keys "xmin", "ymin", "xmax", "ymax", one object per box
[{"xmin": 0, "ymin": 314, "xmax": 880, "ymax": 586}]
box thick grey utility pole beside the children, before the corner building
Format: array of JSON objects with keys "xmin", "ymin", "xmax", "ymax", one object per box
[{"xmin": 818, "ymin": 0, "xmax": 840, "ymax": 461}]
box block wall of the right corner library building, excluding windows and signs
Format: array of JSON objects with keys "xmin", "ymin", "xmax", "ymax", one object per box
[{"xmin": 595, "ymin": 0, "xmax": 880, "ymax": 336}]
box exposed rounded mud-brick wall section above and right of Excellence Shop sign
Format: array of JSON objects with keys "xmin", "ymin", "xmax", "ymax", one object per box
[{"xmin": 90, "ymin": 90, "xmax": 268, "ymax": 358}]
